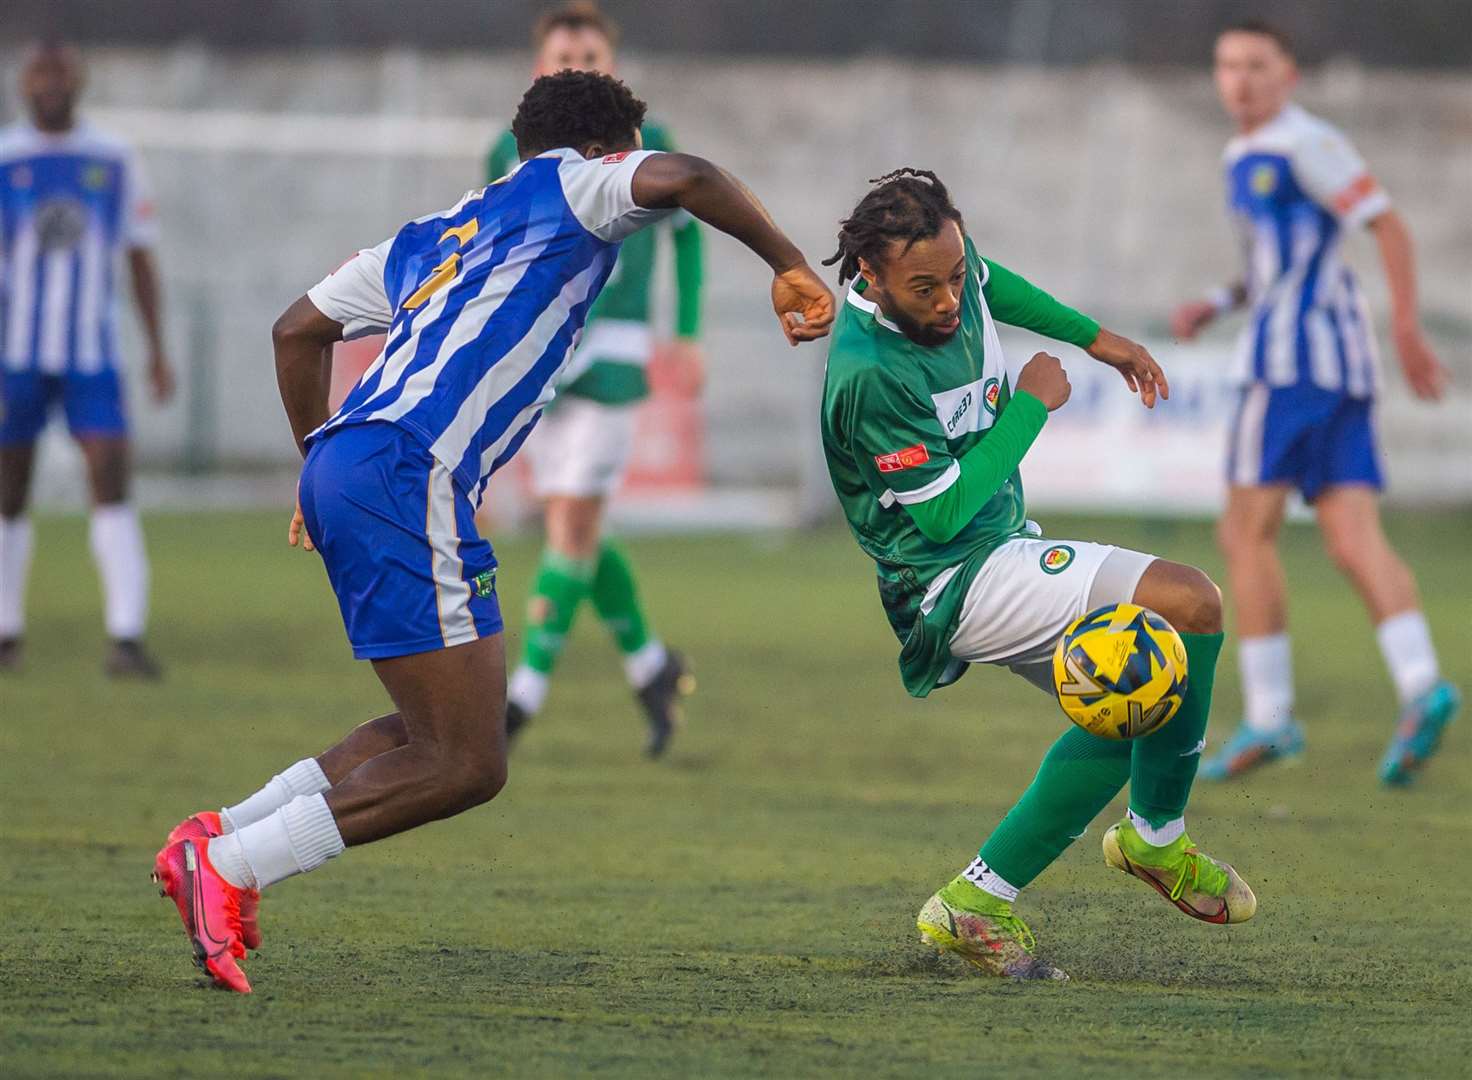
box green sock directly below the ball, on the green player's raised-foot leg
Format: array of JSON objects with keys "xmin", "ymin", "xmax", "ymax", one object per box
[{"xmin": 1129, "ymin": 634, "xmax": 1225, "ymax": 828}]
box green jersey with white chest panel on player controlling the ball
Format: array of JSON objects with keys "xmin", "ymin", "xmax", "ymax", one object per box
[{"xmin": 821, "ymin": 237, "xmax": 1098, "ymax": 697}]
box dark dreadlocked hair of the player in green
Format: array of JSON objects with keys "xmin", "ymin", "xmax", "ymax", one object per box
[{"xmin": 823, "ymin": 165, "xmax": 964, "ymax": 285}]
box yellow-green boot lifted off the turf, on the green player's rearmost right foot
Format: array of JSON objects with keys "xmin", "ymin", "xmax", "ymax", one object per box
[{"xmin": 1104, "ymin": 818, "xmax": 1257, "ymax": 924}]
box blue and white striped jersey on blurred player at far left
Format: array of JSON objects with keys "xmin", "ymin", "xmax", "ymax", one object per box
[{"xmin": 0, "ymin": 124, "xmax": 155, "ymax": 375}]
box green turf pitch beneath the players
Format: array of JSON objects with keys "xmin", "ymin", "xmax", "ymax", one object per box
[{"xmin": 0, "ymin": 515, "xmax": 1472, "ymax": 1077}]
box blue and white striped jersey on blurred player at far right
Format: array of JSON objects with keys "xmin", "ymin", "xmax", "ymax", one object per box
[{"xmin": 1225, "ymin": 104, "xmax": 1390, "ymax": 397}]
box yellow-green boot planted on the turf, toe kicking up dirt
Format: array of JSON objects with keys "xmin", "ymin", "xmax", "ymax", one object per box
[{"xmin": 916, "ymin": 875, "xmax": 1069, "ymax": 978}]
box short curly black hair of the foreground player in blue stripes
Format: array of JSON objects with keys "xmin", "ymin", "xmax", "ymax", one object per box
[{"xmin": 511, "ymin": 71, "xmax": 648, "ymax": 160}]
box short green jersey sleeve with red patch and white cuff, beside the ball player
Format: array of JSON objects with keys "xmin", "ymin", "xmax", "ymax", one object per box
[{"xmin": 849, "ymin": 368, "xmax": 961, "ymax": 506}]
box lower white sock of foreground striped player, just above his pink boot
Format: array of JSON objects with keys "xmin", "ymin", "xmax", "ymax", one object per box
[{"xmin": 209, "ymin": 795, "xmax": 343, "ymax": 889}]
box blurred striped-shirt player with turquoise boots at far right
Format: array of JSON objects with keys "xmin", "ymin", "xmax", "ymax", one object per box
[{"xmin": 1172, "ymin": 22, "xmax": 1459, "ymax": 784}]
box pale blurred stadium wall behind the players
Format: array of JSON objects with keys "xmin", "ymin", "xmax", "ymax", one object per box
[{"xmin": 0, "ymin": 46, "xmax": 1472, "ymax": 508}]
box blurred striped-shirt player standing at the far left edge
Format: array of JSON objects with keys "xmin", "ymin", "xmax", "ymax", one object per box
[{"xmin": 0, "ymin": 43, "xmax": 174, "ymax": 678}]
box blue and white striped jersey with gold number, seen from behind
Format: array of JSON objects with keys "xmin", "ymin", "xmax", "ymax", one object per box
[{"xmin": 308, "ymin": 149, "xmax": 670, "ymax": 503}]
